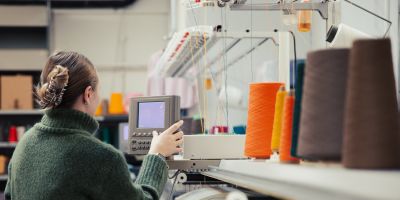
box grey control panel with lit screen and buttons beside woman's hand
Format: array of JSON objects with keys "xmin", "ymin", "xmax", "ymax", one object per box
[{"xmin": 128, "ymin": 96, "xmax": 180, "ymax": 155}]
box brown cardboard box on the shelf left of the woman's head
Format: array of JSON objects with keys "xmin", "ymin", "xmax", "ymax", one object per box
[{"xmin": 0, "ymin": 75, "xmax": 33, "ymax": 110}]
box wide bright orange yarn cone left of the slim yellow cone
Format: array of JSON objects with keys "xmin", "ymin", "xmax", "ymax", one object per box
[{"xmin": 244, "ymin": 83, "xmax": 283, "ymax": 159}]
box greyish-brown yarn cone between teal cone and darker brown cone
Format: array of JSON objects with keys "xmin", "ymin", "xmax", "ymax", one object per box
[{"xmin": 297, "ymin": 49, "xmax": 350, "ymax": 161}]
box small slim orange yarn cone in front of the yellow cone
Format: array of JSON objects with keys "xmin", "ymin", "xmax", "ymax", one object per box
[{"xmin": 279, "ymin": 90, "xmax": 299, "ymax": 163}]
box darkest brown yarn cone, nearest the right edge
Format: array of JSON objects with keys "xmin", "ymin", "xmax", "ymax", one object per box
[{"xmin": 343, "ymin": 39, "xmax": 400, "ymax": 169}]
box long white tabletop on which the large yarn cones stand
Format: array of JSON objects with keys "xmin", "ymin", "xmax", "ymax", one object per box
[{"xmin": 203, "ymin": 160, "xmax": 400, "ymax": 200}]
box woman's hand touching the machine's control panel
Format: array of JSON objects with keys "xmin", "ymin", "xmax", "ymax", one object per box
[{"xmin": 149, "ymin": 120, "xmax": 183, "ymax": 157}]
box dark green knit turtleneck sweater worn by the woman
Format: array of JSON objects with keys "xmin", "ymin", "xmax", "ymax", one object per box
[{"xmin": 5, "ymin": 109, "xmax": 167, "ymax": 200}]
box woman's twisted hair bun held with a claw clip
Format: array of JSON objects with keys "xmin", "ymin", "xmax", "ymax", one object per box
[{"xmin": 36, "ymin": 65, "xmax": 69, "ymax": 109}]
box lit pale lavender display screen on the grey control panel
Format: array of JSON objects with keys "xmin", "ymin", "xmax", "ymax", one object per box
[{"xmin": 138, "ymin": 102, "xmax": 165, "ymax": 128}]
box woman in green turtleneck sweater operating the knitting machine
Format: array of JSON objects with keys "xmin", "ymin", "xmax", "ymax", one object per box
[{"xmin": 5, "ymin": 52, "xmax": 183, "ymax": 200}]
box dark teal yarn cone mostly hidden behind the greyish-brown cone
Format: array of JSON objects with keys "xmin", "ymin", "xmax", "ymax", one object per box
[{"xmin": 290, "ymin": 63, "xmax": 305, "ymax": 157}]
